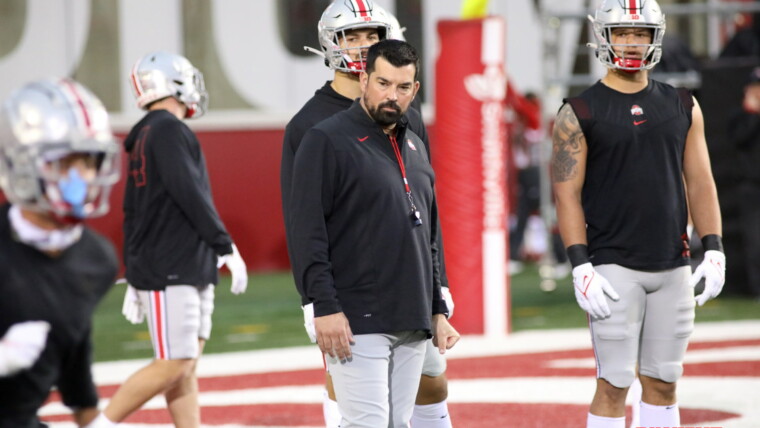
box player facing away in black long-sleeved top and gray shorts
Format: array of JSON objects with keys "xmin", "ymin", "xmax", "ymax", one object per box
[{"xmin": 89, "ymin": 52, "xmax": 248, "ymax": 428}]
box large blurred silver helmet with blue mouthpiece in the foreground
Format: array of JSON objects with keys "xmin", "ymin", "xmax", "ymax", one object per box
[{"xmin": 0, "ymin": 79, "xmax": 121, "ymax": 221}]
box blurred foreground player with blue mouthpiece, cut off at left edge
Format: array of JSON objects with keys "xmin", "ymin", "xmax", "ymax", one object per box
[{"xmin": 0, "ymin": 79, "xmax": 120, "ymax": 428}]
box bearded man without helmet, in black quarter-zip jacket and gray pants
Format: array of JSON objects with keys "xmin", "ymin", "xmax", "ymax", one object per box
[{"xmin": 289, "ymin": 40, "xmax": 459, "ymax": 428}]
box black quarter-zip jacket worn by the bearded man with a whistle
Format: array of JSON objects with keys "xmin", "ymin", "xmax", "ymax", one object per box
[{"xmin": 289, "ymin": 101, "xmax": 446, "ymax": 334}]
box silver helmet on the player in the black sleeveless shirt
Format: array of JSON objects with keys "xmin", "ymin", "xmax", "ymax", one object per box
[{"xmin": 588, "ymin": 0, "xmax": 665, "ymax": 72}]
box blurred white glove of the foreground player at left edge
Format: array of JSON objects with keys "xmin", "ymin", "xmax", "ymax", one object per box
[{"xmin": 0, "ymin": 321, "xmax": 50, "ymax": 376}]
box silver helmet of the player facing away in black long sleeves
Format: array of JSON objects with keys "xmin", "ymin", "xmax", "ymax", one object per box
[{"xmin": 130, "ymin": 52, "xmax": 208, "ymax": 119}]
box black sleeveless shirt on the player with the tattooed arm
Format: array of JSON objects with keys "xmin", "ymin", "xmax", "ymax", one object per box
[{"xmin": 565, "ymin": 80, "xmax": 693, "ymax": 270}]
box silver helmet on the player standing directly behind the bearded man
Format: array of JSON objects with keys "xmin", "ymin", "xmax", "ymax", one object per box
[{"xmin": 317, "ymin": 0, "xmax": 392, "ymax": 74}]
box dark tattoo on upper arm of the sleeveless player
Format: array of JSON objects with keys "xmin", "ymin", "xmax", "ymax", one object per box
[{"xmin": 551, "ymin": 104, "xmax": 583, "ymax": 182}]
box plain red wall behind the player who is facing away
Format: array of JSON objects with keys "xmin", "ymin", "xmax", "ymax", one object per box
[{"xmin": 90, "ymin": 129, "xmax": 289, "ymax": 271}]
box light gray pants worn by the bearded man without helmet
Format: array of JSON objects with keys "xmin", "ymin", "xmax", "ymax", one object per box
[{"xmin": 325, "ymin": 330, "xmax": 427, "ymax": 428}]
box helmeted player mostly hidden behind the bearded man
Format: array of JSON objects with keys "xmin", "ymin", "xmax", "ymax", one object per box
[{"xmin": 280, "ymin": 1, "xmax": 454, "ymax": 428}]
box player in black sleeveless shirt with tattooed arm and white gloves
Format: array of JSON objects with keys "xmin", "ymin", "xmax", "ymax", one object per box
[{"xmin": 551, "ymin": 0, "xmax": 725, "ymax": 428}]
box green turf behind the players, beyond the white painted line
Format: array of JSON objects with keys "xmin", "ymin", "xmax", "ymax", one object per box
[{"xmin": 93, "ymin": 265, "xmax": 760, "ymax": 361}]
